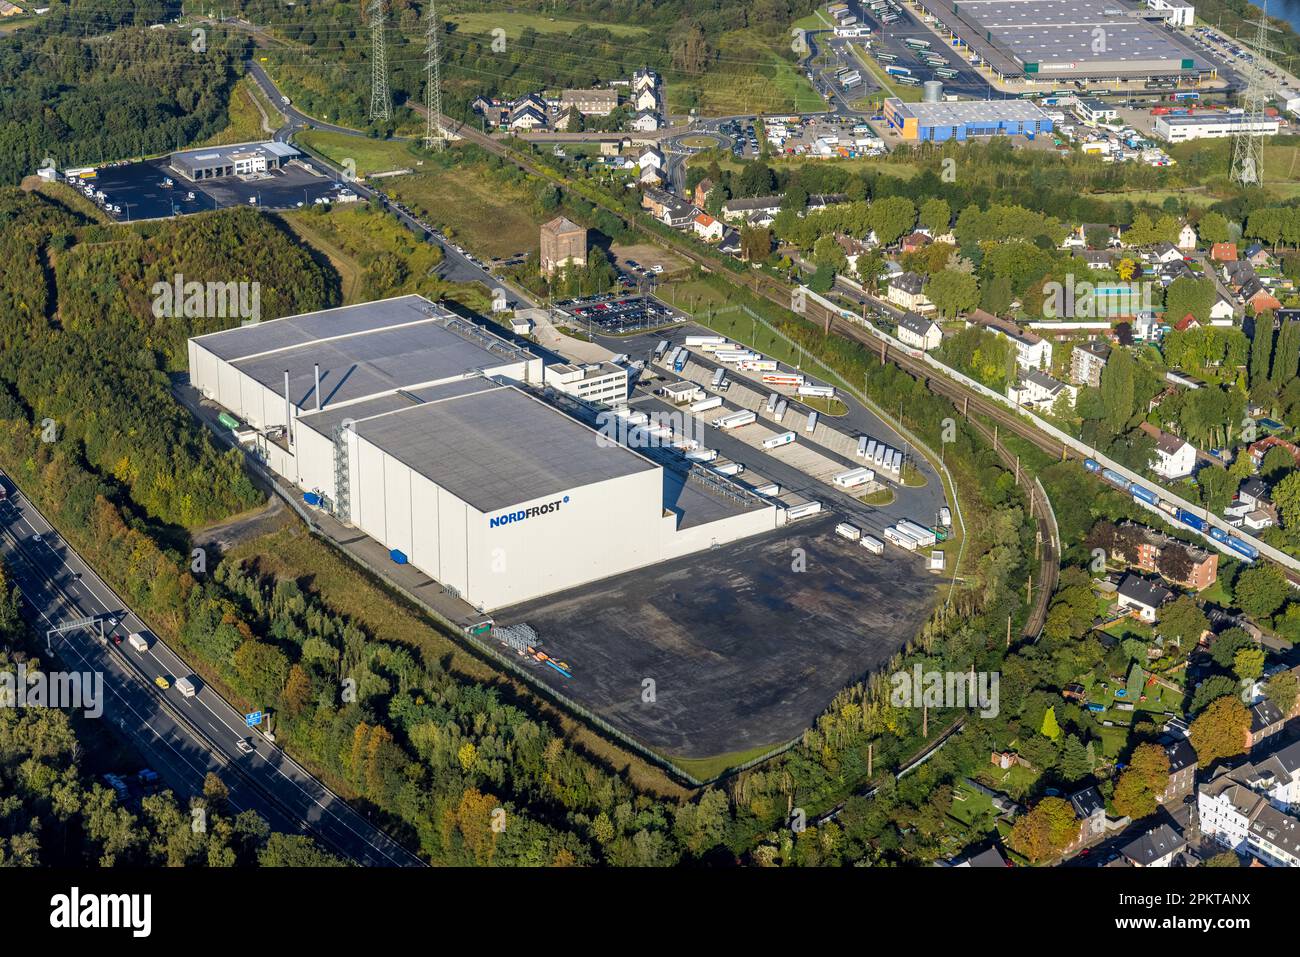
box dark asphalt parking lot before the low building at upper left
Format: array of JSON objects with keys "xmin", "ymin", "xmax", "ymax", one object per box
[{"xmin": 69, "ymin": 159, "xmax": 343, "ymax": 222}]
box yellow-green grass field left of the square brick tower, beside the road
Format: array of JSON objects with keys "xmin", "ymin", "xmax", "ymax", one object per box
[{"xmin": 386, "ymin": 164, "xmax": 542, "ymax": 256}]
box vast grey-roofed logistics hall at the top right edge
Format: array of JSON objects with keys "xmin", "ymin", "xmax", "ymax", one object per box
[{"xmin": 919, "ymin": 0, "xmax": 1216, "ymax": 83}]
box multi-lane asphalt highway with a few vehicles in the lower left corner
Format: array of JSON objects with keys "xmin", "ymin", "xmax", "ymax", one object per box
[{"xmin": 3, "ymin": 481, "xmax": 421, "ymax": 866}]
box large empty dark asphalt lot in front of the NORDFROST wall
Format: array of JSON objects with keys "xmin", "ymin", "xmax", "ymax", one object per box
[{"xmin": 495, "ymin": 515, "xmax": 943, "ymax": 758}]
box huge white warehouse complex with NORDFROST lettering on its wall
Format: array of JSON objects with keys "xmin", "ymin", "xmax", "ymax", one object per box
[{"xmin": 189, "ymin": 296, "xmax": 777, "ymax": 610}]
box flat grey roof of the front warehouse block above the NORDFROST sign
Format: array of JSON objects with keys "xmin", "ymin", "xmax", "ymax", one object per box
[{"xmin": 354, "ymin": 386, "xmax": 658, "ymax": 512}]
